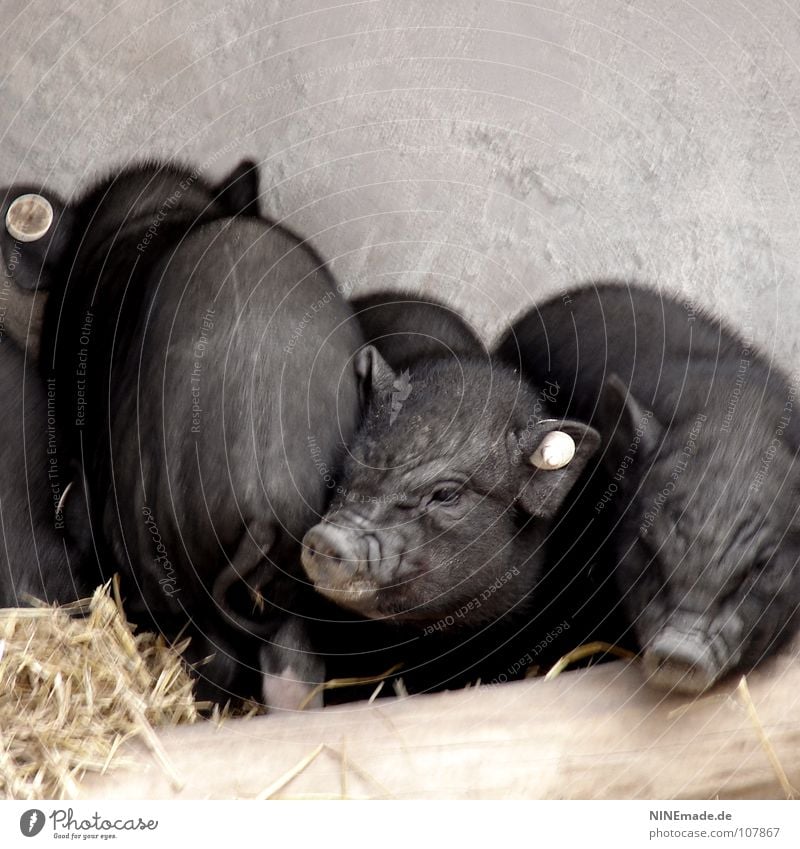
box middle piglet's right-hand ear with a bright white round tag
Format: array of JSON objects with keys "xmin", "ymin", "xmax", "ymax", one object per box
[{"xmin": 509, "ymin": 419, "xmax": 600, "ymax": 519}]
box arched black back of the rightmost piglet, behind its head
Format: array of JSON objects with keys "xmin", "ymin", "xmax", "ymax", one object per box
[{"xmin": 498, "ymin": 283, "xmax": 783, "ymax": 430}]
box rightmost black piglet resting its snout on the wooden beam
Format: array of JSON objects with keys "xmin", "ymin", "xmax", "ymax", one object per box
[{"xmin": 498, "ymin": 283, "xmax": 800, "ymax": 693}]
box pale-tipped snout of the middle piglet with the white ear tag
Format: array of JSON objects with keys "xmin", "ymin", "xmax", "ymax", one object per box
[{"xmin": 302, "ymin": 522, "xmax": 380, "ymax": 612}]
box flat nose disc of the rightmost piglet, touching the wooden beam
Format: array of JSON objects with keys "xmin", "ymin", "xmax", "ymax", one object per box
[{"xmin": 644, "ymin": 634, "xmax": 719, "ymax": 696}]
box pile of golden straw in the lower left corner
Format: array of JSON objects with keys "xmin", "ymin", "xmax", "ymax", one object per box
[{"xmin": 0, "ymin": 585, "xmax": 198, "ymax": 799}]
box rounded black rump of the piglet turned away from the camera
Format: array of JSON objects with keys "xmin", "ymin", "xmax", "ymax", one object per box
[{"xmin": 111, "ymin": 219, "xmax": 361, "ymax": 568}]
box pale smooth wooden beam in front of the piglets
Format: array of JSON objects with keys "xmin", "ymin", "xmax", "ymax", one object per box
[{"xmin": 82, "ymin": 644, "xmax": 800, "ymax": 799}]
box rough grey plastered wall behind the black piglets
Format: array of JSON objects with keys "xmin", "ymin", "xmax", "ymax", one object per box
[{"xmin": 0, "ymin": 0, "xmax": 800, "ymax": 366}]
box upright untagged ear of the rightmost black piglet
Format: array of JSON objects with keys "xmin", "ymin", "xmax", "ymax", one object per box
[{"xmin": 597, "ymin": 374, "xmax": 664, "ymax": 469}]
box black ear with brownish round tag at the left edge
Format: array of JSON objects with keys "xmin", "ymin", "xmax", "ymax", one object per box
[{"xmin": 0, "ymin": 186, "xmax": 73, "ymax": 290}]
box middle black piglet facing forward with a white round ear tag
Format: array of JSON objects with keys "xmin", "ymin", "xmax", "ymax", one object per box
[{"xmin": 302, "ymin": 320, "xmax": 600, "ymax": 691}]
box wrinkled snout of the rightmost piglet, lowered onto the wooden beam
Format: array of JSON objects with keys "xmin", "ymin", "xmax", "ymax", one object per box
[{"xmin": 644, "ymin": 613, "xmax": 730, "ymax": 695}]
